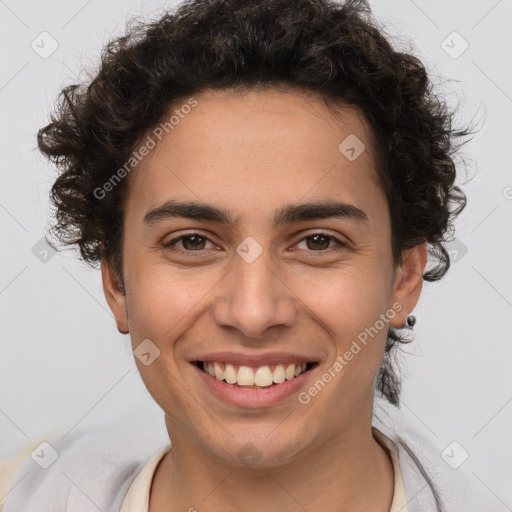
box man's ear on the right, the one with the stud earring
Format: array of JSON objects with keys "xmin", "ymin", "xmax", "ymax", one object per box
[{"xmin": 390, "ymin": 242, "xmax": 427, "ymax": 329}]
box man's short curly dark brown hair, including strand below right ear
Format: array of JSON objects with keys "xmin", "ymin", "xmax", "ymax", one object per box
[{"xmin": 38, "ymin": 0, "xmax": 472, "ymax": 405}]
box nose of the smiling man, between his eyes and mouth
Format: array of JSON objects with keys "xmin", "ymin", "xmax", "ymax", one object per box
[{"xmin": 212, "ymin": 251, "xmax": 297, "ymax": 338}]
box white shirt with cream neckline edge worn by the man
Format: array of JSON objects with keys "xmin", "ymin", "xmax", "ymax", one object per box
[{"xmin": 0, "ymin": 403, "xmax": 486, "ymax": 512}]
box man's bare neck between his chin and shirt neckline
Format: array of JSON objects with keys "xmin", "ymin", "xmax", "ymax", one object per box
[{"xmin": 149, "ymin": 417, "xmax": 394, "ymax": 512}]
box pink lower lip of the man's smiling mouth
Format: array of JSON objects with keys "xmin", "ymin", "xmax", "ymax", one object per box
[{"xmin": 192, "ymin": 364, "xmax": 315, "ymax": 409}]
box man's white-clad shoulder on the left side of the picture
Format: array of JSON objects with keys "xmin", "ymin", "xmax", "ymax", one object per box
[{"xmin": 1, "ymin": 424, "xmax": 168, "ymax": 512}]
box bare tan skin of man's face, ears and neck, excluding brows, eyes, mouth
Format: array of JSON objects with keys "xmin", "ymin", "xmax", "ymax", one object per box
[{"xmin": 102, "ymin": 89, "xmax": 426, "ymax": 512}]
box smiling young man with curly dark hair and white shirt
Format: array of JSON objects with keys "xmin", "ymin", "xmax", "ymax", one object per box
[{"xmin": 5, "ymin": 0, "xmax": 478, "ymax": 512}]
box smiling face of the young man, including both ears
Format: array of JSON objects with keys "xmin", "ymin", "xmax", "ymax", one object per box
[{"xmin": 102, "ymin": 89, "xmax": 425, "ymax": 466}]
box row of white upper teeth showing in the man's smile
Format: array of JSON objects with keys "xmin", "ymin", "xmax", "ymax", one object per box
[{"xmin": 203, "ymin": 361, "xmax": 306, "ymax": 387}]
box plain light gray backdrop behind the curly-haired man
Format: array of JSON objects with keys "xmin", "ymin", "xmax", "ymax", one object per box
[{"xmin": 0, "ymin": 0, "xmax": 512, "ymax": 511}]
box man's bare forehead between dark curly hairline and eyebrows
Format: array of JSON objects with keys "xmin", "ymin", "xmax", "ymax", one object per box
[{"xmin": 128, "ymin": 89, "xmax": 380, "ymax": 226}]
